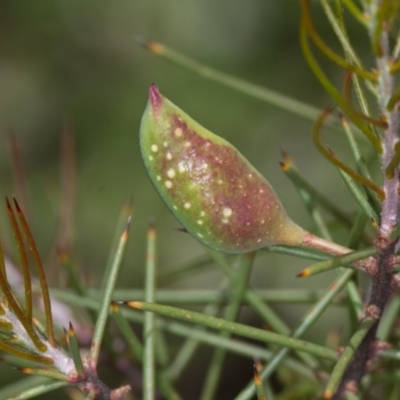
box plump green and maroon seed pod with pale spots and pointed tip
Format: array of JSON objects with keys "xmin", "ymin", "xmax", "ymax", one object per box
[{"xmin": 140, "ymin": 84, "xmax": 305, "ymax": 253}]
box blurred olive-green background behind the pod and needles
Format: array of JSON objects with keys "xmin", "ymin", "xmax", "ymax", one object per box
[{"xmin": 0, "ymin": 0, "xmax": 370, "ymax": 398}]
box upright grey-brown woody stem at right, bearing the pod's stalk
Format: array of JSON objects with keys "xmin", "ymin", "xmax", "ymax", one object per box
[{"xmin": 327, "ymin": 0, "xmax": 399, "ymax": 400}]
